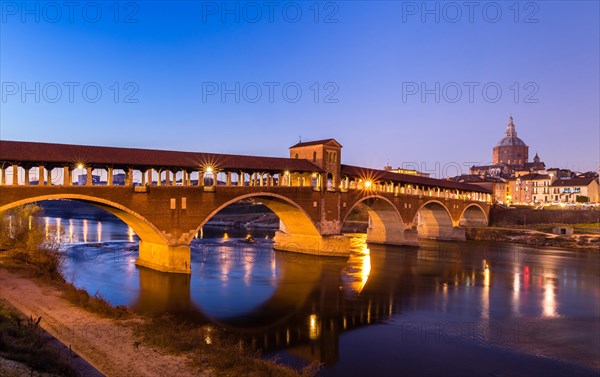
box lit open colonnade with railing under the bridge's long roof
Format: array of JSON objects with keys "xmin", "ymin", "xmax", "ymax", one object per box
[{"xmin": 0, "ymin": 164, "xmax": 492, "ymax": 203}]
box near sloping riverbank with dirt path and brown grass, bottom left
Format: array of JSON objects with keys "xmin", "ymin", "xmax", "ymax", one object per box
[{"xmin": 0, "ymin": 256, "xmax": 310, "ymax": 377}]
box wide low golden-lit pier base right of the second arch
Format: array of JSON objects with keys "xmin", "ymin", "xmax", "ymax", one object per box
[{"xmin": 273, "ymin": 231, "xmax": 351, "ymax": 256}]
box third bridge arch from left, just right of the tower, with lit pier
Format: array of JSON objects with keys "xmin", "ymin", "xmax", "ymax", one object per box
[{"xmin": 344, "ymin": 196, "xmax": 416, "ymax": 245}]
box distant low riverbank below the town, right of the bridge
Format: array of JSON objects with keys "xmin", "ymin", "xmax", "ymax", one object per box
[{"xmin": 465, "ymin": 227, "xmax": 600, "ymax": 251}]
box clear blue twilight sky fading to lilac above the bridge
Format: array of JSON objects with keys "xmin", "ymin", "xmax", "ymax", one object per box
[{"xmin": 0, "ymin": 1, "xmax": 600, "ymax": 177}]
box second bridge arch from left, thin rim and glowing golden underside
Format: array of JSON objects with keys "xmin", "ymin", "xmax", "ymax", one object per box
[{"xmin": 188, "ymin": 192, "xmax": 321, "ymax": 242}]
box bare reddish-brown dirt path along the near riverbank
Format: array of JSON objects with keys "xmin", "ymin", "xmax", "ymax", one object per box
[{"xmin": 0, "ymin": 268, "xmax": 203, "ymax": 377}]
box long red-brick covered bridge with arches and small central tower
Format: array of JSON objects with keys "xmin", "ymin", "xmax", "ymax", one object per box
[{"xmin": 0, "ymin": 139, "xmax": 491, "ymax": 273}]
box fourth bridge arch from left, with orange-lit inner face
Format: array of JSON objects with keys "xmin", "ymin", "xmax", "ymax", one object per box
[{"xmin": 413, "ymin": 201, "xmax": 465, "ymax": 240}]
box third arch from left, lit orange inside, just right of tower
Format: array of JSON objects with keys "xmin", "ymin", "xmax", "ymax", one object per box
[{"xmin": 342, "ymin": 195, "xmax": 416, "ymax": 245}]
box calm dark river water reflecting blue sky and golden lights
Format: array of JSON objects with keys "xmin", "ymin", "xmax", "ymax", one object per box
[{"xmin": 45, "ymin": 217, "xmax": 600, "ymax": 376}]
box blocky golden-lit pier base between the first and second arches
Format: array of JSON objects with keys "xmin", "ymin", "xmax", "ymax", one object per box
[{"xmin": 135, "ymin": 240, "xmax": 192, "ymax": 274}]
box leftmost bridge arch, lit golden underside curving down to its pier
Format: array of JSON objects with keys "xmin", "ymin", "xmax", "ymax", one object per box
[{"xmin": 0, "ymin": 194, "xmax": 169, "ymax": 244}]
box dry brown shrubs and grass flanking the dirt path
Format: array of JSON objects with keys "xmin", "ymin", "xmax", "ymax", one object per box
[{"xmin": 0, "ymin": 205, "xmax": 320, "ymax": 376}]
